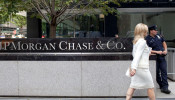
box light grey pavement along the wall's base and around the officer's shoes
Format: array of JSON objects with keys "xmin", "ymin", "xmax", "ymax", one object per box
[{"xmin": 0, "ymin": 80, "xmax": 175, "ymax": 100}]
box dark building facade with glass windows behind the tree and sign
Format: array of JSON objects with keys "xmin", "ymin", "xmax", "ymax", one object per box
[{"xmin": 27, "ymin": 0, "xmax": 175, "ymax": 46}]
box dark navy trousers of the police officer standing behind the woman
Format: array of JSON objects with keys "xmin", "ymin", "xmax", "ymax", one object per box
[{"xmin": 156, "ymin": 55, "xmax": 168, "ymax": 89}]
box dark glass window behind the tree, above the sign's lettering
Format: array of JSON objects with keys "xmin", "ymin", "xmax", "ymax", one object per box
[{"xmin": 42, "ymin": 14, "xmax": 104, "ymax": 38}]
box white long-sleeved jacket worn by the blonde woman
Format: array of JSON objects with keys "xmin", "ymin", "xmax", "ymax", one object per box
[{"xmin": 131, "ymin": 39, "xmax": 151, "ymax": 69}]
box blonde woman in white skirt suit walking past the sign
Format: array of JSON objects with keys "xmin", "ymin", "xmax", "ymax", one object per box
[{"xmin": 126, "ymin": 23, "xmax": 155, "ymax": 100}]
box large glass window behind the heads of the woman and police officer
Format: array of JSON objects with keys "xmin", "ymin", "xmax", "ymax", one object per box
[{"xmin": 117, "ymin": 9, "xmax": 175, "ymax": 40}]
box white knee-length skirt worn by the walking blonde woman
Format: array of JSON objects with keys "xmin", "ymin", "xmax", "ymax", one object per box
[{"xmin": 130, "ymin": 68, "xmax": 154, "ymax": 89}]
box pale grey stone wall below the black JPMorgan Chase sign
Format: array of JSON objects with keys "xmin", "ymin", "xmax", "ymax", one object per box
[{"xmin": 0, "ymin": 60, "xmax": 156, "ymax": 97}]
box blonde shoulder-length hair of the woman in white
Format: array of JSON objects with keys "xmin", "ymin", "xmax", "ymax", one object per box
[{"xmin": 133, "ymin": 23, "xmax": 148, "ymax": 44}]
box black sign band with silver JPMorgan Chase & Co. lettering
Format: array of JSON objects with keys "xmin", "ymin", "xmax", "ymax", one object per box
[{"xmin": 0, "ymin": 38, "xmax": 132, "ymax": 53}]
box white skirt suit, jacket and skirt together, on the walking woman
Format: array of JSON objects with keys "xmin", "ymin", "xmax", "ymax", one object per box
[{"xmin": 130, "ymin": 39, "xmax": 154, "ymax": 89}]
